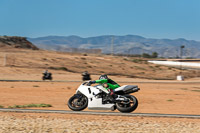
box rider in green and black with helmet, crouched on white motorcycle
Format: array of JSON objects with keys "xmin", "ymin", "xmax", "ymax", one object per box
[{"xmin": 89, "ymin": 74, "xmax": 120, "ymax": 98}]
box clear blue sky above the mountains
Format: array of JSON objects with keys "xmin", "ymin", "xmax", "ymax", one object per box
[{"xmin": 0, "ymin": 0, "xmax": 200, "ymax": 41}]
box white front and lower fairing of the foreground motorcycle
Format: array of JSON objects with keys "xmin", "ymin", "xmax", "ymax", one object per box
[{"xmin": 76, "ymin": 84, "xmax": 115, "ymax": 110}]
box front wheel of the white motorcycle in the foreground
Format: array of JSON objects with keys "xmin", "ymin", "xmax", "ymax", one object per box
[{"xmin": 67, "ymin": 94, "xmax": 88, "ymax": 111}]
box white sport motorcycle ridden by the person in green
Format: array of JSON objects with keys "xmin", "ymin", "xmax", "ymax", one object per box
[{"xmin": 68, "ymin": 82, "xmax": 140, "ymax": 113}]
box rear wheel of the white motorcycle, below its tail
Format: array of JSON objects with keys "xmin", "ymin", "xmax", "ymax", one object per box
[{"xmin": 116, "ymin": 95, "xmax": 138, "ymax": 113}]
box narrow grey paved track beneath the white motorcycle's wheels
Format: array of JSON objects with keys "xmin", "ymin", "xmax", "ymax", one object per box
[{"xmin": 0, "ymin": 108, "xmax": 200, "ymax": 119}]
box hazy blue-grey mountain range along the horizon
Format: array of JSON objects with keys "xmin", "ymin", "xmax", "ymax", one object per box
[{"xmin": 28, "ymin": 35, "xmax": 200, "ymax": 58}]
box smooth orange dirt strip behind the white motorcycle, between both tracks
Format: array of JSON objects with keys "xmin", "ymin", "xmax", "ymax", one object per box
[{"xmin": 0, "ymin": 77, "xmax": 200, "ymax": 114}]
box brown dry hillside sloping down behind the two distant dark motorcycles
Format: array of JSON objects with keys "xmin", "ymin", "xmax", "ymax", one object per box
[{"xmin": 0, "ymin": 49, "xmax": 200, "ymax": 80}]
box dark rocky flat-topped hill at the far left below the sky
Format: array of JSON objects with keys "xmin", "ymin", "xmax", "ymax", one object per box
[{"xmin": 0, "ymin": 36, "xmax": 39, "ymax": 50}]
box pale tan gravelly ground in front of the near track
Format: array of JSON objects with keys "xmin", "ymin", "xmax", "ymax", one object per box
[{"xmin": 0, "ymin": 113, "xmax": 200, "ymax": 133}]
